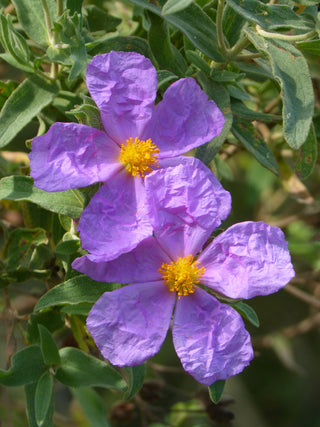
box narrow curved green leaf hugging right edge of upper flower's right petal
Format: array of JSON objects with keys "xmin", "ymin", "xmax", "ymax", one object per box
[{"xmin": 196, "ymin": 72, "xmax": 232, "ymax": 164}]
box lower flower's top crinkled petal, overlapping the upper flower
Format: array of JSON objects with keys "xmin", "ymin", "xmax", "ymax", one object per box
[{"xmin": 145, "ymin": 156, "xmax": 231, "ymax": 256}]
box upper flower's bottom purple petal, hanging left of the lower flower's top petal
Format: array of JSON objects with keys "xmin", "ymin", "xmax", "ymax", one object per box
[{"xmin": 78, "ymin": 171, "xmax": 152, "ymax": 261}]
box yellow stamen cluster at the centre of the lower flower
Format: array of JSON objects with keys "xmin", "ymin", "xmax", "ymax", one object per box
[{"xmin": 158, "ymin": 255, "xmax": 206, "ymax": 299}]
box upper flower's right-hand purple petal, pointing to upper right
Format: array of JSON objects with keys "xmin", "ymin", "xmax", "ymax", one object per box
[{"xmin": 144, "ymin": 78, "xmax": 224, "ymax": 158}]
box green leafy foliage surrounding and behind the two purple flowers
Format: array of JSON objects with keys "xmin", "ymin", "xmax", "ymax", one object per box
[{"xmin": 0, "ymin": 0, "xmax": 320, "ymax": 427}]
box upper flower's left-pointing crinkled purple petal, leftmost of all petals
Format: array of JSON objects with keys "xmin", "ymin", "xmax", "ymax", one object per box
[{"xmin": 29, "ymin": 123, "xmax": 123, "ymax": 191}]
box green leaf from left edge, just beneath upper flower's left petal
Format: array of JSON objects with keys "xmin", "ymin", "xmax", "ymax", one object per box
[{"xmin": 0, "ymin": 176, "xmax": 83, "ymax": 218}]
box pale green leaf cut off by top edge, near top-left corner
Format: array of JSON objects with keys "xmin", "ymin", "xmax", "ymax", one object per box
[{"xmin": 12, "ymin": 0, "xmax": 57, "ymax": 46}]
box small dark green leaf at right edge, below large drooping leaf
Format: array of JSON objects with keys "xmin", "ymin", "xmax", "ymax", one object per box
[{"xmin": 295, "ymin": 125, "xmax": 318, "ymax": 179}]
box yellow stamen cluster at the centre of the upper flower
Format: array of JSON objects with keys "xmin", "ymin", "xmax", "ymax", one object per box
[{"xmin": 119, "ymin": 137, "xmax": 160, "ymax": 177}]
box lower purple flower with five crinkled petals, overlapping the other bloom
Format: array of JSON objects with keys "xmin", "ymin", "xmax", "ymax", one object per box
[{"xmin": 73, "ymin": 159, "xmax": 294, "ymax": 385}]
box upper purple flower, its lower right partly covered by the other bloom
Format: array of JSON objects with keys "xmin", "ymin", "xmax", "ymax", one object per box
[{"xmin": 30, "ymin": 52, "xmax": 224, "ymax": 260}]
